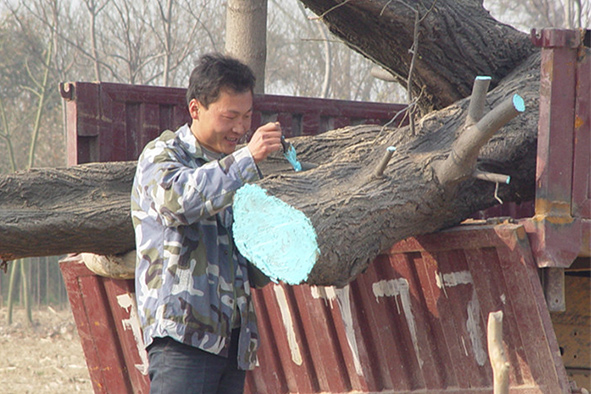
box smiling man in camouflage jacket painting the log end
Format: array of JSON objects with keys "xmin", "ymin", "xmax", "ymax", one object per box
[{"xmin": 131, "ymin": 54, "xmax": 281, "ymax": 393}]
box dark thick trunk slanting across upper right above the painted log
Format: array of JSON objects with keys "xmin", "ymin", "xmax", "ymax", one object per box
[{"xmin": 300, "ymin": 0, "xmax": 534, "ymax": 114}]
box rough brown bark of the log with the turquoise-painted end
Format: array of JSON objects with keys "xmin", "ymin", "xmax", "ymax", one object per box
[{"xmin": 259, "ymin": 56, "xmax": 539, "ymax": 285}]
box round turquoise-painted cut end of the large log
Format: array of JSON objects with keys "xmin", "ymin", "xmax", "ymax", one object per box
[{"xmin": 232, "ymin": 185, "xmax": 320, "ymax": 285}]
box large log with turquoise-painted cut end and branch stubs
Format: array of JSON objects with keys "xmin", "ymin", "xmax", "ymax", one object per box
[{"xmin": 234, "ymin": 59, "xmax": 537, "ymax": 286}]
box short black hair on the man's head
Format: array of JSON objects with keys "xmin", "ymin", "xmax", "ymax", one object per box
[{"xmin": 187, "ymin": 53, "xmax": 256, "ymax": 108}]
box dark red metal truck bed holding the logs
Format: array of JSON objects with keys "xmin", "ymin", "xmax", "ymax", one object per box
[{"xmin": 61, "ymin": 30, "xmax": 591, "ymax": 393}]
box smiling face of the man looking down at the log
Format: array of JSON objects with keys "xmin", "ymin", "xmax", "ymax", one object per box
[{"xmin": 189, "ymin": 89, "xmax": 252, "ymax": 154}]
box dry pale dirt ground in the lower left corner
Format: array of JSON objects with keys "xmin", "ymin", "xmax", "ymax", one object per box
[{"xmin": 0, "ymin": 307, "xmax": 93, "ymax": 394}]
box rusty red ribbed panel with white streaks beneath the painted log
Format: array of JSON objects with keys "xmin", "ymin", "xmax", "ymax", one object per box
[{"xmin": 247, "ymin": 224, "xmax": 569, "ymax": 393}]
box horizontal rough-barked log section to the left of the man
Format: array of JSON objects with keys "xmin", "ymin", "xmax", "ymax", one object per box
[{"xmin": 0, "ymin": 162, "xmax": 135, "ymax": 260}]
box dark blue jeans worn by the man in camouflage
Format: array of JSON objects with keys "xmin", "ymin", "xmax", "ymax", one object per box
[{"xmin": 148, "ymin": 330, "xmax": 246, "ymax": 394}]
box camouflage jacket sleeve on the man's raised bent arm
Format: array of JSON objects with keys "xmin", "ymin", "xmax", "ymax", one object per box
[{"xmin": 136, "ymin": 147, "xmax": 259, "ymax": 227}]
